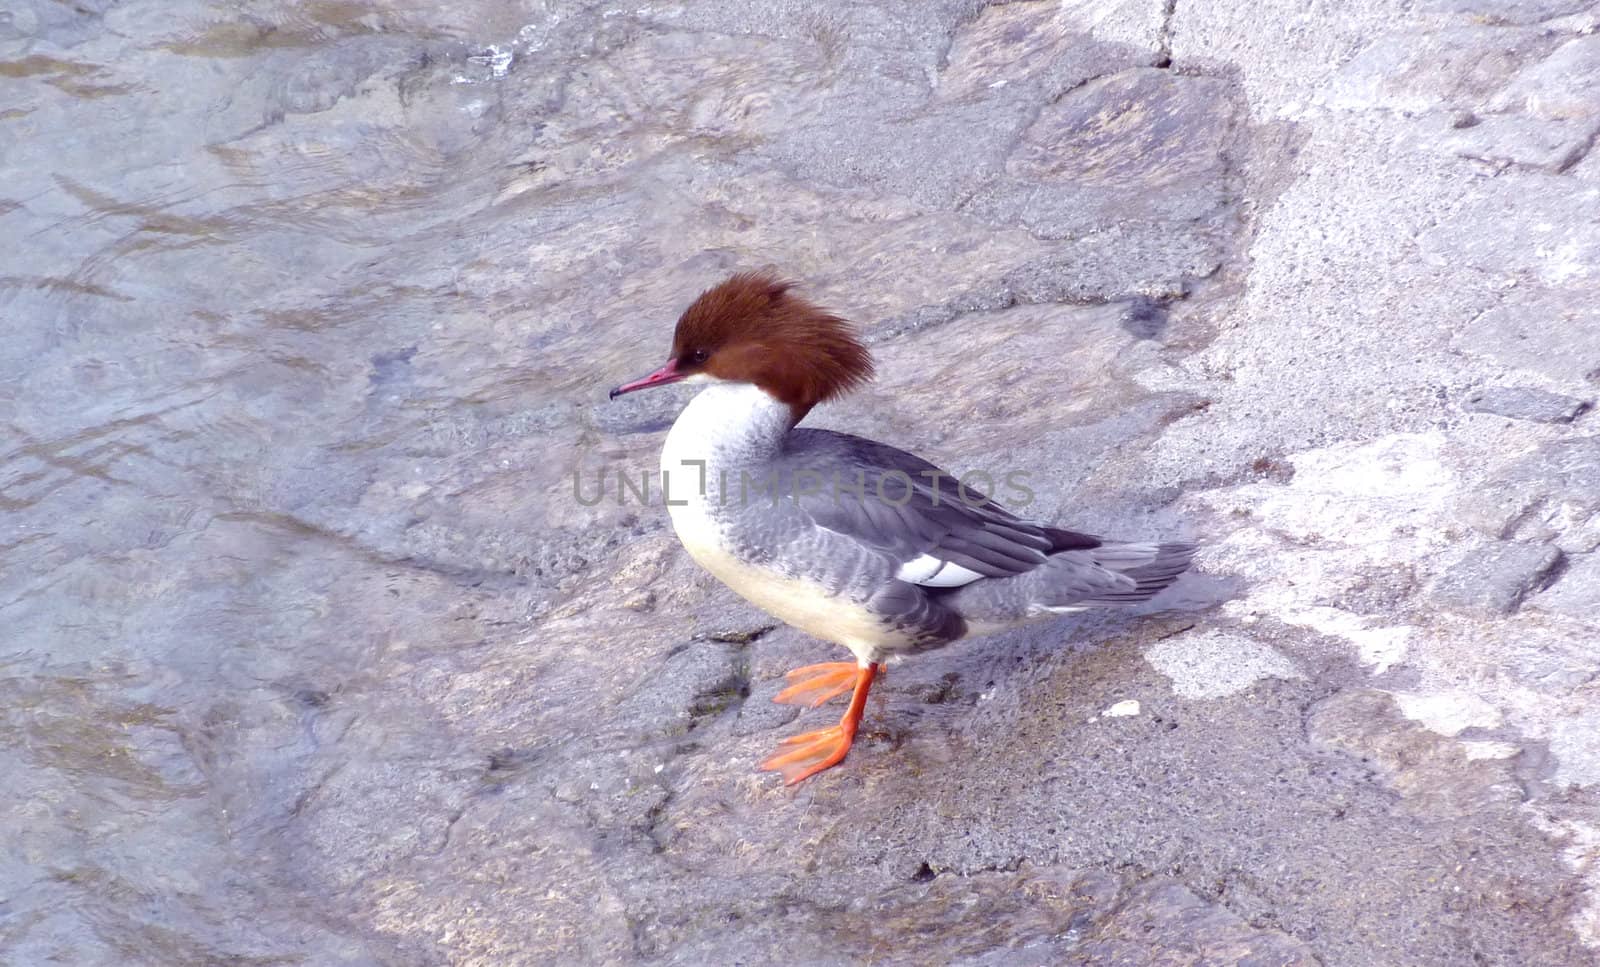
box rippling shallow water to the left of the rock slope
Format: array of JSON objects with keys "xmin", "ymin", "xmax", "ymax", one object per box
[{"xmin": 0, "ymin": 0, "xmax": 624, "ymax": 964}]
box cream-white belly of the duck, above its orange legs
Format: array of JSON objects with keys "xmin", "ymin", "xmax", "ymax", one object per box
[{"xmin": 672, "ymin": 508, "xmax": 910, "ymax": 660}]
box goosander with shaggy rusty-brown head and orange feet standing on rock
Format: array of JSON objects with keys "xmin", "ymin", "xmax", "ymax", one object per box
[{"xmin": 611, "ymin": 272, "xmax": 1195, "ymax": 784}]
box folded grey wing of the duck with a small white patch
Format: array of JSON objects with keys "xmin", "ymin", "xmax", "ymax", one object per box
[{"xmin": 774, "ymin": 429, "xmax": 1099, "ymax": 588}]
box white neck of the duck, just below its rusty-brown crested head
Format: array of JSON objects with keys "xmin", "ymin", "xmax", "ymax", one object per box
[{"xmin": 661, "ymin": 383, "xmax": 794, "ymax": 477}]
